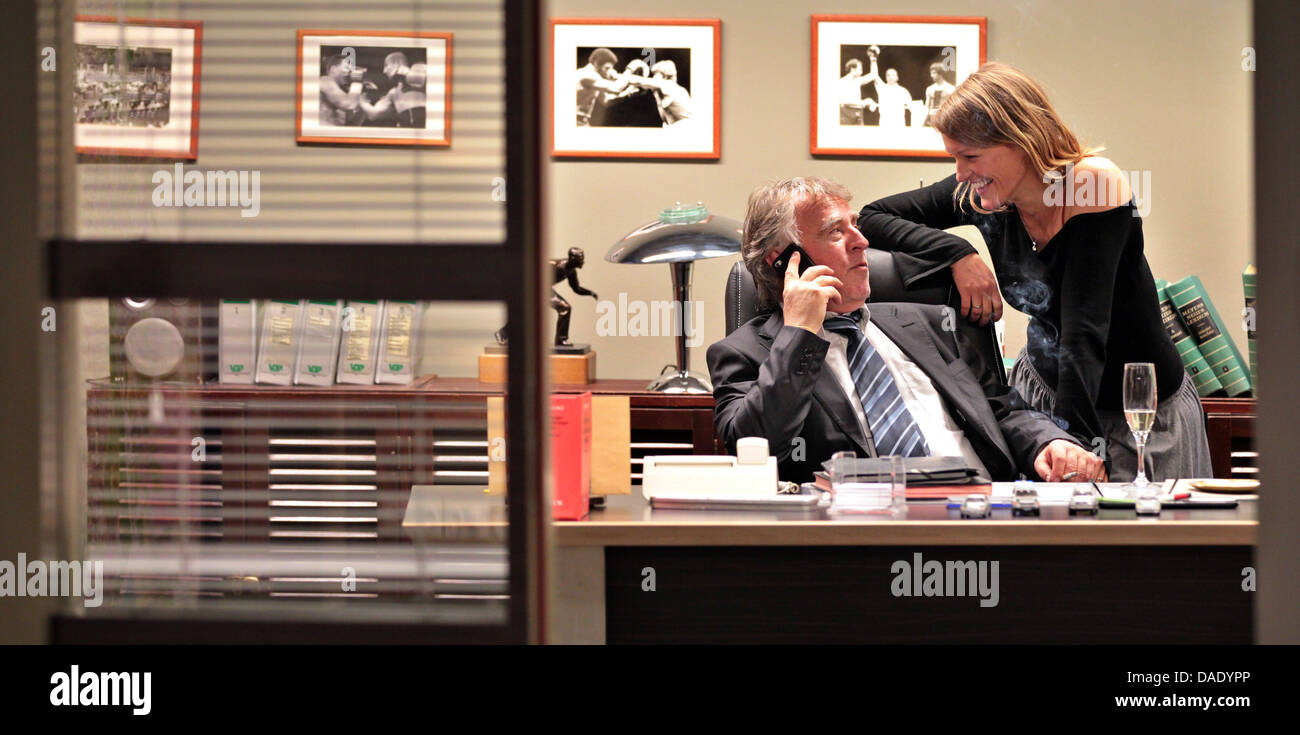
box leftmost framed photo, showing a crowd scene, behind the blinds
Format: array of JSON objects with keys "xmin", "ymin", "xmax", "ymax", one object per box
[{"xmin": 73, "ymin": 16, "xmax": 203, "ymax": 161}]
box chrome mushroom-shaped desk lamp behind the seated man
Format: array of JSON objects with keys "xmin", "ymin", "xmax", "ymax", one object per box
[{"xmin": 605, "ymin": 202, "xmax": 741, "ymax": 393}]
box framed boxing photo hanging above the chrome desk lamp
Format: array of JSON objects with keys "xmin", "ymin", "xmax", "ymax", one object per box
[{"xmin": 551, "ymin": 18, "xmax": 722, "ymax": 159}]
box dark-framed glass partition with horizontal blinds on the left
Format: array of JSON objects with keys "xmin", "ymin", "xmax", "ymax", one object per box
[{"xmin": 42, "ymin": 0, "xmax": 540, "ymax": 636}]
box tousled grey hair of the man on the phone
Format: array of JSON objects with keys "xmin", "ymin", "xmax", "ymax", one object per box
[{"xmin": 740, "ymin": 176, "xmax": 853, "ymax": 308}]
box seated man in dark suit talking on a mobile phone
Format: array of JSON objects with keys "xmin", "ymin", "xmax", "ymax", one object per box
[{"xmin": 707, "ymin": 177, "xmax": 1105, "ymax": 481}]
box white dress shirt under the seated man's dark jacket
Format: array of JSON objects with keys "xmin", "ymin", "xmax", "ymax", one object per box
[{"xmin": 818, "ymin": 307, "xmax": 989, "ymax": 477}]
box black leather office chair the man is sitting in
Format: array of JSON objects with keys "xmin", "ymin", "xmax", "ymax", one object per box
[{"xmin": 724, "ymin": 248, "xmax": 1006, "ymax": 385}]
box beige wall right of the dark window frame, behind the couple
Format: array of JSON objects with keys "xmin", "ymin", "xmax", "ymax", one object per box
[{"xmin": 547, "ymin": 0, "xmax": 1255, "ymax": 377}]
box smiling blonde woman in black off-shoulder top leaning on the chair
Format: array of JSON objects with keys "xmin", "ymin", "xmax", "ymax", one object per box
[{"xmin": 858, "ymin": 64, "xmax": 1213, "ymax": 481}]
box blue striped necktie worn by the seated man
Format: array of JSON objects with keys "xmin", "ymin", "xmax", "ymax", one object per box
[{"xmin": 824, "ymin": 310, "xmax": 930, "ymax": 457}]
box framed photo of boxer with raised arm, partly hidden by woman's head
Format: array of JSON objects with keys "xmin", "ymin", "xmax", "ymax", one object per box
[{"xmin": 811, "ymin": 16, "xmax": 988, "ymax": 157}]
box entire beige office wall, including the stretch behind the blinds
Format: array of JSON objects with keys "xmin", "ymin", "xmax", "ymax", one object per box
[{"xmin": 68, "ymin": 0, "xmax": 1253, "ymax": 380}]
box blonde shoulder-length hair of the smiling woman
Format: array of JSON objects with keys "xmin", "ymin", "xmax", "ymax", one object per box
[{"xmin": 931, "ymin": 61, "xmax": 1102, "ymax": 215}]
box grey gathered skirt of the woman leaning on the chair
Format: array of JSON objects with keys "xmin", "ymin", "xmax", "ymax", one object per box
[{"xmin": 1010, "ymin": 350, "xmax": 1214, "ymax": 483}]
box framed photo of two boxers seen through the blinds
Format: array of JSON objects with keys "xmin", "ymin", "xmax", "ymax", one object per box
[{"xmin": 295, "ymin": 29, "xmax": 452, "ymax": 147}]
